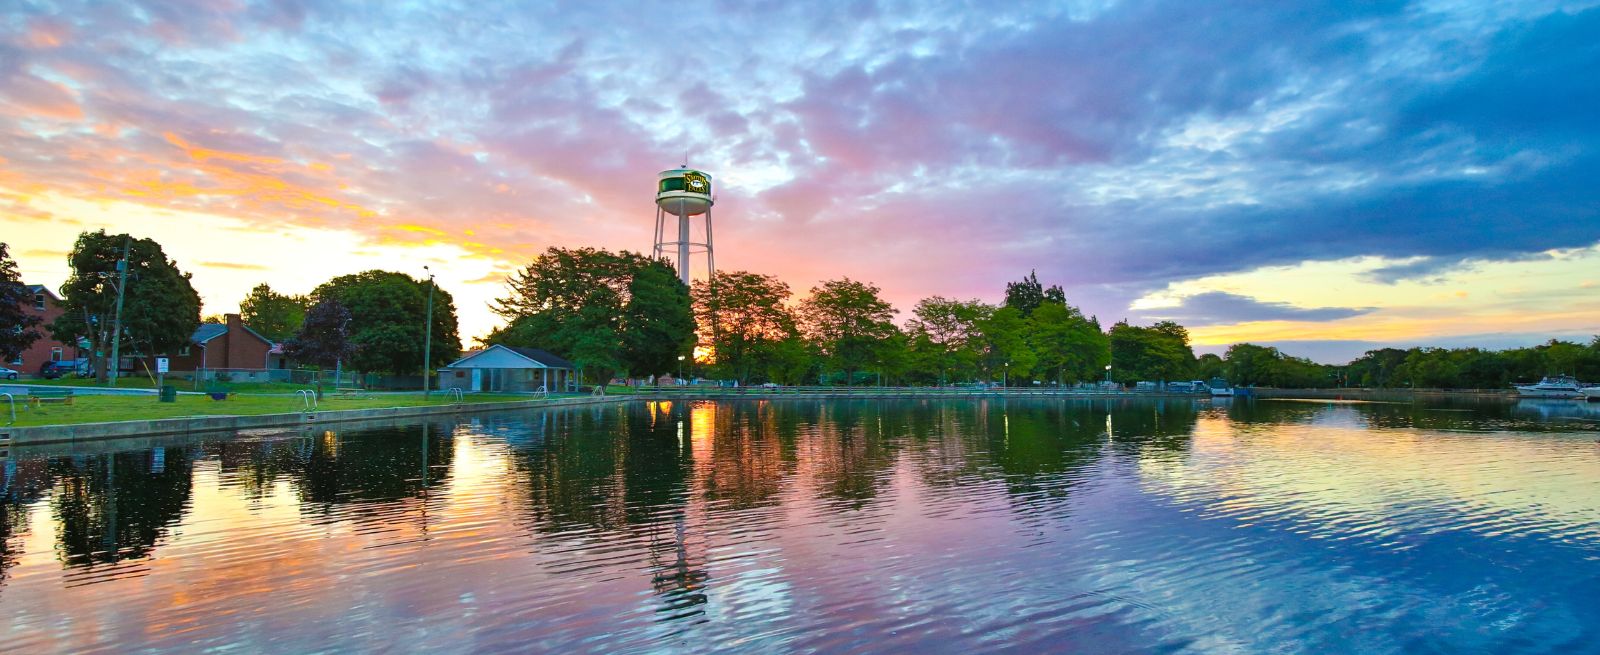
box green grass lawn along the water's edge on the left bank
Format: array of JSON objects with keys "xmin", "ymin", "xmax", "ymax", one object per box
[{"xmin": 0, "ymin": 392, "xmax": 556, "ymax": 428}]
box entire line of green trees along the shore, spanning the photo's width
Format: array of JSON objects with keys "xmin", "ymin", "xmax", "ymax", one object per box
[{"xmin": 0, "ymin": 231, "xmax": 1600, "ymax": 389}]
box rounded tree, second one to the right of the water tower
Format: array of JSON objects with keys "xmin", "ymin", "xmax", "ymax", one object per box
[{"xmin": 800, "ymin": 277, "xmax": 899, "ymax": 384}]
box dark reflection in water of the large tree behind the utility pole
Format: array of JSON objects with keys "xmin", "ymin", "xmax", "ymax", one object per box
[{"xmin": 50, "ymin": 448, "xmax": 194, "ymax": 565}]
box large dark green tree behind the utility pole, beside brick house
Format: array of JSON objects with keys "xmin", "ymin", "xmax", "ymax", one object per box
[{"xmin": 50, "ymin": 231, "xmax": 200, "ymax": 381}]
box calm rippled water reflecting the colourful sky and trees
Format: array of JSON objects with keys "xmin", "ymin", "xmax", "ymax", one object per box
[{"xmin": 0, "ymin": 400, "xmax": 1600, "ymax": 653}]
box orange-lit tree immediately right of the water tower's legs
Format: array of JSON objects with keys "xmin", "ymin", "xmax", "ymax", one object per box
[{"xmin": 694, "ymin": 271, "xmax": 798, "ymax": 383}]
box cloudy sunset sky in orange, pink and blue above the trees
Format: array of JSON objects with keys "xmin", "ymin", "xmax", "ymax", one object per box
[{"xmin": 0, "ymin": 0, "xmax": 1600, "ymax": 362}]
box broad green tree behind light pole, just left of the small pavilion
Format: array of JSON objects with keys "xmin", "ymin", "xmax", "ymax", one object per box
[{"xmin": 310, "ymin": 271, "xmax": 461, "ymax": 375}]
